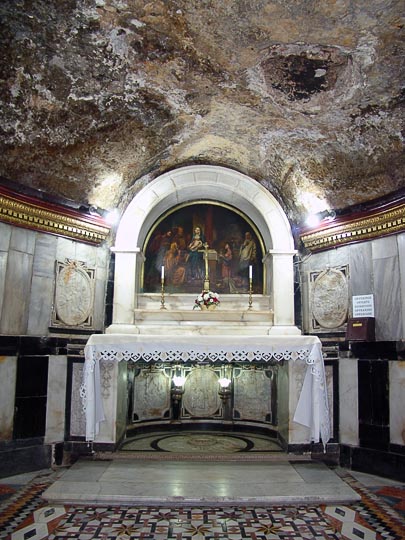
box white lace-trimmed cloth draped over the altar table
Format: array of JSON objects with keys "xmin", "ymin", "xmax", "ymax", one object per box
[{"xmin": 81, "ymin": 334, "xmax": 331, "ymax": 445}]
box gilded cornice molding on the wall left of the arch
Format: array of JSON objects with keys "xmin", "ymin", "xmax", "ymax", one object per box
[{"xmin": 0, "ymin": 186, "xmax": 110, "ymax": 245}]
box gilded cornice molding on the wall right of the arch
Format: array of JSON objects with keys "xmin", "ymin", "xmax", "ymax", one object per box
[{"xmin": 300, "ymin": 200, "xmax": 405, "ymax": 252}]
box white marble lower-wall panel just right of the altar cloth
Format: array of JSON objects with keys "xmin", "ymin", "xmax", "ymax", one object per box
[{"xmin": 339, "ymin": 358, "xmax": 359, "ymax": 446}]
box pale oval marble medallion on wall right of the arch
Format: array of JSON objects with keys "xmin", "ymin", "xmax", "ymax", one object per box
[{"xmin": 311, "ymin": 268, "xmax": 349, "ymax": 328}]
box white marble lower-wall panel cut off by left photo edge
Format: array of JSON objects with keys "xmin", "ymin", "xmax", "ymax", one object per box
[{"xmin": 0, "ymin": 356, "xmax": 17, "ymax": 441}]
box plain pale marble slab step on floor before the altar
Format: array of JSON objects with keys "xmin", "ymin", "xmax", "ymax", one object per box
[{"xmin": 42, "ymin": 459, "xmax": 359, "ymax": 506}]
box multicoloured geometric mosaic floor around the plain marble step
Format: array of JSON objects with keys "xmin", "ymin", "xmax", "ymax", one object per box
[{"xmin": 0, "ymin": 469, "xmax": 405, "ymax": 540}]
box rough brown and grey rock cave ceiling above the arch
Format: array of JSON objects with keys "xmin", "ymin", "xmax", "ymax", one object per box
[{"xmin": 0, "ymin": 0, "xmax": 405, "ymax": 226}]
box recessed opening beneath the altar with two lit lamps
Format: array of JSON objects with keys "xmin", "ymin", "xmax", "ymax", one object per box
[{"xmin": 121, "ymin": 361, "xmax": 285, "ymax": 453}]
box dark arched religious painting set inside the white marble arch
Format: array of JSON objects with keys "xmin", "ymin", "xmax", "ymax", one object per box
[{"xmin": 143, "ymin": 203, "xmax": 263, "ymax": 294}]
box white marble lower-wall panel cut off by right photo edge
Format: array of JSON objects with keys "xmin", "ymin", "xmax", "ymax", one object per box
[{"xmin": 389, "ymin": 361, "xmax": 405, "ymax": 446}]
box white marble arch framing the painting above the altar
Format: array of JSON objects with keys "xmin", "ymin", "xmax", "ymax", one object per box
[{"xmin": 107, "ymin": 165, "xmax": 300, "ymax": 334}]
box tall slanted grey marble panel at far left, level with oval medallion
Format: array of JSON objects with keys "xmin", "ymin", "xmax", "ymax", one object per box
[{"xmin": 0, "ymin": 250, "xmax": 33, "ymax": 335}]
